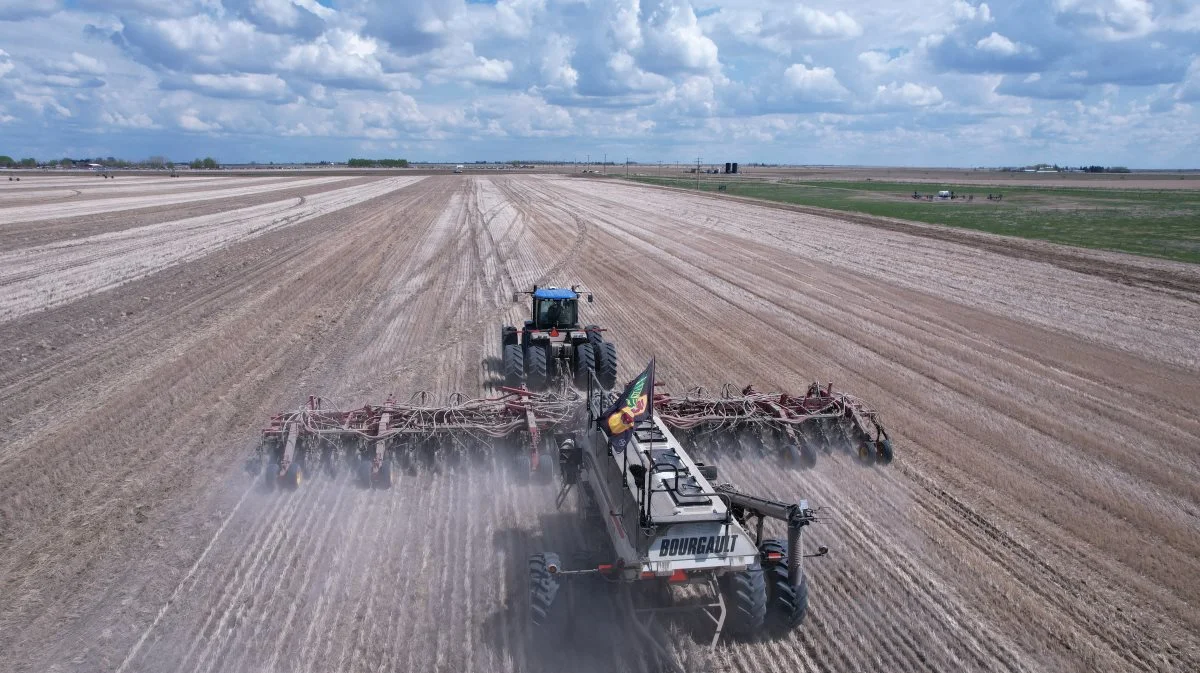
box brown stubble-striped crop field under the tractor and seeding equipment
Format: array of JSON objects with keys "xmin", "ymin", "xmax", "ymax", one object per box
[{"xmin": 0, "ymin": 175, "xmax": 1200, "ymax": 673}]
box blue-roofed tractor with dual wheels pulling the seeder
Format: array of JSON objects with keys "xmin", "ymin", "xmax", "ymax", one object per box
[{"xmin": 500, "ymin": 286, "xmax": 617, "ymax": 391}]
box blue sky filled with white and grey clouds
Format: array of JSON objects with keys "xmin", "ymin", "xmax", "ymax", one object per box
[{"xmin": 0, "ymin": 0, "xmax": 1200, "ymax": 168}]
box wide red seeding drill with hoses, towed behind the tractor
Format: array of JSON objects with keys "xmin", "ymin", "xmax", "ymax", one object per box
[{"xmin": 247, "ymin": 383, "xmax": 892, "ymax": 488}]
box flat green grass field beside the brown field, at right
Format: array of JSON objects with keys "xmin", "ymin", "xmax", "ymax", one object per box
[{"xmin": 630, "ymin": 175, "xmax": 1200, "ymax": 263}]
